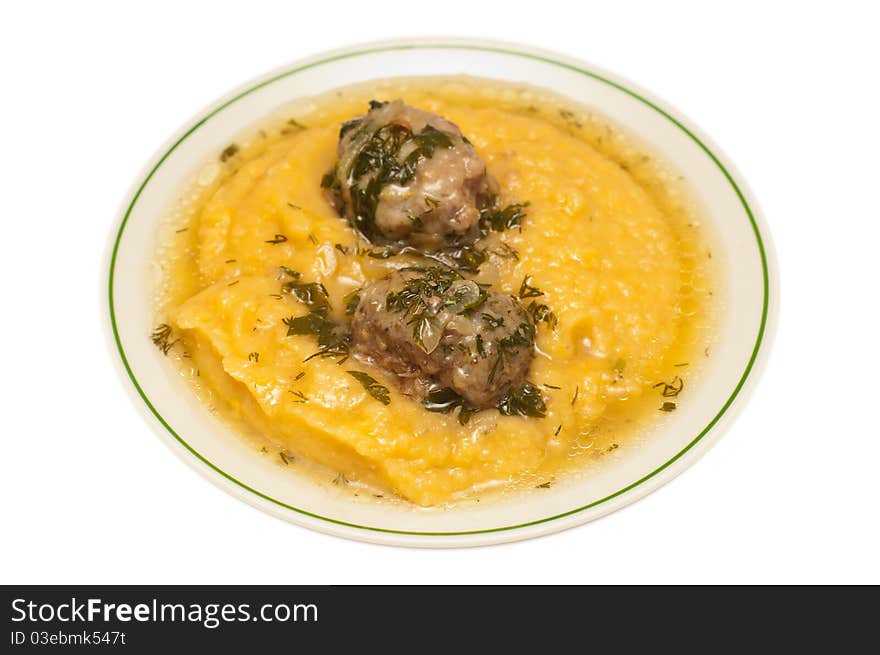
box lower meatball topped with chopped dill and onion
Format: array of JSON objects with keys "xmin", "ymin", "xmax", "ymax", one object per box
[{"xmin": 352, "ymin": 266, "xmax": 535, "ymax": 409}]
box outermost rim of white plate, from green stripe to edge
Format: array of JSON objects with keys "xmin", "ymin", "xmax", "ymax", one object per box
[{"xmin": 102, "ymin": 37, "xmax": 778, "ymax": 547}]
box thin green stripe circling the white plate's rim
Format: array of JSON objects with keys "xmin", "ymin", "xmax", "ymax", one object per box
[{"xmin": 108, "ymin": 43, "xmax": 770, "ymax": 537}]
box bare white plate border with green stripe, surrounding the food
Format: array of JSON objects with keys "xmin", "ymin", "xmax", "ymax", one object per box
[{"xmin": 107, "ymin": 39, "xmax": 778, "ymax": 547}]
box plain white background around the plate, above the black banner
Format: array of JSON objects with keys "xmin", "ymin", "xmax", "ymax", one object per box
[{"xmin": 0, "ymin": 0, "xmax": 880, "ymax": 583}]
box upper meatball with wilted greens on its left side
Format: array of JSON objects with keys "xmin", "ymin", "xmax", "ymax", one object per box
[{"xmin": 324, "ymin": 100, "xmax": 497, "ymax": 250}]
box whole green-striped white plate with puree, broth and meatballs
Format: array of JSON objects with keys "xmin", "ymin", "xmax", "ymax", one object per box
[{"xmin": 107, "ymin": 40, "xmax": 776, "ymax": 547}]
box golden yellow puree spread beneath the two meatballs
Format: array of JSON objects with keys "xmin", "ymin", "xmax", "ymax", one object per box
[{"xmin": 157, "ymin": 78, "xmax": 716, "ymax": 505}]
